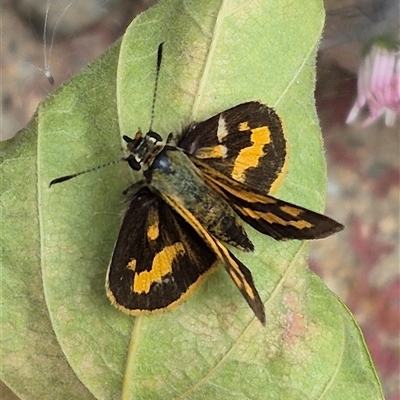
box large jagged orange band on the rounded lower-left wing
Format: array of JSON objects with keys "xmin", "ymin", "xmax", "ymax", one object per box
[{"xmin": 132, "ymin": 242, "xmax": 185, "ymax": 293}]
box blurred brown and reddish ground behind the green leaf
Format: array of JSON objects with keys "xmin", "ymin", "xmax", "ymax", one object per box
[{"xmin": 0, "ymin": 0, "xmax": 400, "ymax": 400}]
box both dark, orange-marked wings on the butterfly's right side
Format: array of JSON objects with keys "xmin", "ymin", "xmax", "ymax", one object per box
[{"xmin": 179, "ymin": 102, "xmax": 343, "ymax": 240}]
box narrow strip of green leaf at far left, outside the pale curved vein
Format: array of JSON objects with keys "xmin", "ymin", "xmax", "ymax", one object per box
[{"xmin": 0, "ymin": 120, "xmax": 93, "ymax": 400}]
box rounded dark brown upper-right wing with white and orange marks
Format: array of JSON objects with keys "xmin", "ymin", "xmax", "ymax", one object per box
[{"xmin": 179, "ymin": 101, "xmax": 287, "ymax": 194}]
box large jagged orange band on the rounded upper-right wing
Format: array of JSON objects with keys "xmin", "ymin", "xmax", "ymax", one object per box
[{"xmin": 232, "ymin": 126, "xmax": 271, "ymax": 182}]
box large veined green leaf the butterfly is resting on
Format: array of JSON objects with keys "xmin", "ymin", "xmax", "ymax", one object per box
[{"xmin": 1, "ymin": 0, "xmax": 383, "ymax": 399}]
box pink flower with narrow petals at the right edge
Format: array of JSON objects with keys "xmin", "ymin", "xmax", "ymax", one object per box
[{"xmin": 346, "ymin": 40, "xmax": 400, "ymax": 126}]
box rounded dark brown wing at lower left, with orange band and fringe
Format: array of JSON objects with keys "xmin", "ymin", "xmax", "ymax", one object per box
[{"xmin": 106, "ymin": 188, "xmax": 217, "ymax": 314}]
